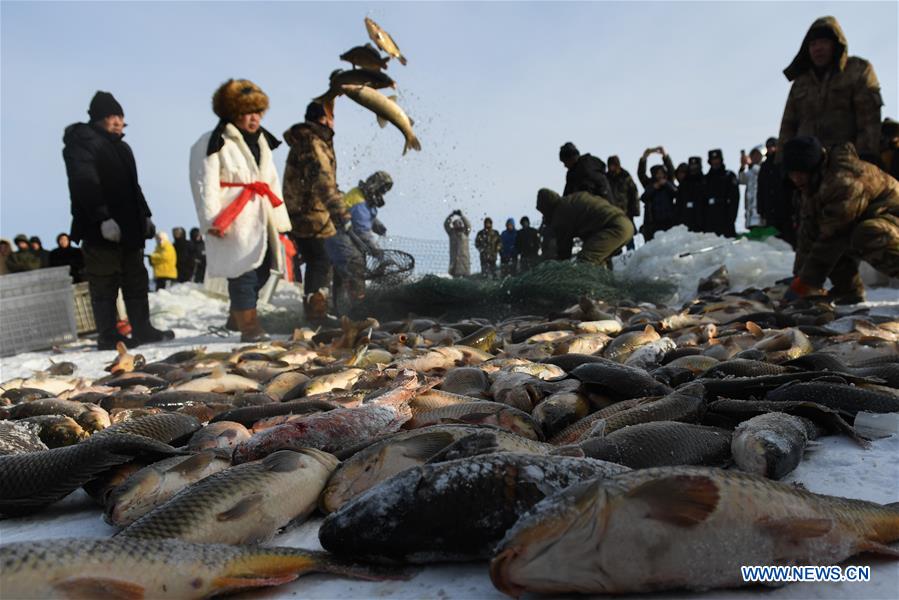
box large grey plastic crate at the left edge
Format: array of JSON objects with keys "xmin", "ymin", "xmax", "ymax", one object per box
[{"xmin": 0, "ymin": 267, "xmax": 78, "ymax": 356}]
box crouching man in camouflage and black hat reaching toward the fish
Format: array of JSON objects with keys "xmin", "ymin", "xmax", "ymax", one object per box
[{"xmin": 783, "ymin": 136, "xmax": 899, "ymax": 304}]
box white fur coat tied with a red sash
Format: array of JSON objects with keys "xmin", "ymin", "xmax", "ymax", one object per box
[{"xmin": 190, "ymin": 123, "xmax": 290, "ymax": 278}]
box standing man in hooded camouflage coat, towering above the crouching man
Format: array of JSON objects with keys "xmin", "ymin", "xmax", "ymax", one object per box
[{"xmin": 779, "ymin": 17, "xmax": 883, "ymax": 163}]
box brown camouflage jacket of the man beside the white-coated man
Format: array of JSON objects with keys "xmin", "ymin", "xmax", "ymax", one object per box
[{"xmin": 283, "ymin": 122, "xmax": 349, "ymax": 238}]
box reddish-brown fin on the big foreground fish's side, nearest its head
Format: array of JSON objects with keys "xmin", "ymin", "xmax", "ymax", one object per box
[{"xmin": 627, "ymin": 475, "xmax": 720, "ymax": 527}]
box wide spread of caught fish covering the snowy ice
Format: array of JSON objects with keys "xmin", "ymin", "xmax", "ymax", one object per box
[{"xmin": 0, "ymin": 280, "xmax": 899, "ymax": 597}]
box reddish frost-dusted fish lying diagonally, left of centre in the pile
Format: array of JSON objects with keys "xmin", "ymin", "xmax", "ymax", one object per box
[{"xmin": 232, "ymin": 404, "xmax": 412, "ymax": 464}]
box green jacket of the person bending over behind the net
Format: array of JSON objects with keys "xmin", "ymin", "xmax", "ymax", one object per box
[{"xmin": 537, "ymin": 190, "xmax": 632, "ymax": 260}]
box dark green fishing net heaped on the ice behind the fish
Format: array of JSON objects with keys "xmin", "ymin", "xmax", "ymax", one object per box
[{"xmin": 353, "ymin": 261, "xmax": 675, "ymax": 319}]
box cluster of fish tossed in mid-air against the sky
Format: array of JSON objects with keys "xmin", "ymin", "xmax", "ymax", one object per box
[{"xmin": 313, "ymin": 17, "xmax": 421, "ymax": 155}]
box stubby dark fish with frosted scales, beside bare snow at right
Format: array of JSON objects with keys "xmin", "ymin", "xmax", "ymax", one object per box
[{"xmin": 731, "ymin": 412, "xmax": 817, "ymax": 479}]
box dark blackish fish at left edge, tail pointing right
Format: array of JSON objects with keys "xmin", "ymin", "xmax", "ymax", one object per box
[{"xmin": 0, "ymin": 434, "xmax": 178, "ymax": 515}]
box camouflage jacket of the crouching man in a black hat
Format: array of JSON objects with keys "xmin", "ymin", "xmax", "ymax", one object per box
[{"xmin": 797, "ymin": 144, "xmax": 899, "ymax": 287}]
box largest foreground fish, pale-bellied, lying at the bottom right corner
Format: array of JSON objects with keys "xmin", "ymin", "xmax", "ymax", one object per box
[{"xmin": 490, "ymin": 467, "xmax": 899, "ymax": 597}]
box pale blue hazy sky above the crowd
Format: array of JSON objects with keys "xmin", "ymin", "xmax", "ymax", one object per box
[{"xmin": 0, "ymin": 0, "xmax": 899, "ymax": 248}]
